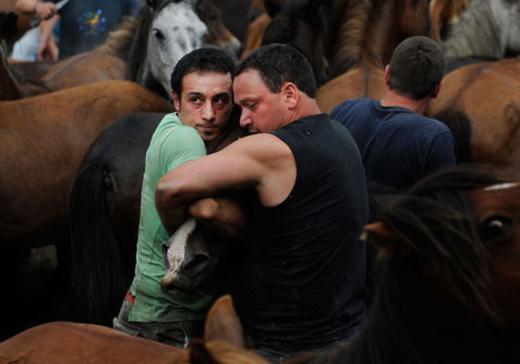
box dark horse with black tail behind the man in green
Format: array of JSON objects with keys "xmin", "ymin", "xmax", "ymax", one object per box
[{"xmin": 63, "ymin": 114, "xmax": 243, "ymax": 325}]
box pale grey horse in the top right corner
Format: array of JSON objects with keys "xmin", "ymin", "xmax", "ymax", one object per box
[{"xmin": 442, "ymin": 0, "xmax": 520, "ymax": 59}]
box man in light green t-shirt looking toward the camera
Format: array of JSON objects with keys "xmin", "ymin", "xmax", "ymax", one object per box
[{"xmin": 113, "ymin": 48, "xmax": 235, "ymax": 347}]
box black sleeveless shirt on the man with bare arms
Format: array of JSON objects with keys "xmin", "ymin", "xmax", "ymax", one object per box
[{"xmin": 242, "ymin": 114, "xmax": 368, "ymax": 353}]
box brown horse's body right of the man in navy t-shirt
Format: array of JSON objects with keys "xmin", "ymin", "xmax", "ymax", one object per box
[{"xmin": 427, "ymin": 58, "xmax": 520, "ymax": 169}]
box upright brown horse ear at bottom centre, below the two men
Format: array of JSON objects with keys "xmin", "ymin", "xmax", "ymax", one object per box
[{"xmin": 204, "ymin": 295, "xmax": 245, "ymax": 348}]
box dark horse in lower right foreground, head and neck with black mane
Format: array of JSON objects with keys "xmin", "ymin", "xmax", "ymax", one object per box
[{"xmin": 280, "ymin": 166, "xmax": 520, "ymax": 364}]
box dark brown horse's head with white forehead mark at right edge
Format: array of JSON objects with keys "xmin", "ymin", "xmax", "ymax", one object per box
[{"xmin": 365, "ymin": 166, "xmax": 520, "ymax": 327}]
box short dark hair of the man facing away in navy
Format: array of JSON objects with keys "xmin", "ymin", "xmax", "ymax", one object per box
[{"xmin": 389, "ymin": 36, "xmax": 445, "ymax": 100}]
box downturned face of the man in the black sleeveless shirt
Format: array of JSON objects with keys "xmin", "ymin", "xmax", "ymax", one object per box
[{"xmin": 233, "ymin": 69, "xmax": 287, "ymax": 133}]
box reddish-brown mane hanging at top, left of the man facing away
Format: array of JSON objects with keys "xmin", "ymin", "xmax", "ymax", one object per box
[{"xmin": 330, "ymin": 0, "xmax": 373, "ymax": 78}]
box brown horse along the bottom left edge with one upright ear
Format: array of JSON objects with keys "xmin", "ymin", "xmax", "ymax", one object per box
[{"xmin": 0, "ymin": 296, "xmax": 267, "ymax": 364}]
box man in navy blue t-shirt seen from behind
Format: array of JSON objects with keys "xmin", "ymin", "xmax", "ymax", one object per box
[{"xmin": 331, "ymin": 36, "xmax": 456, "ymax": 191}]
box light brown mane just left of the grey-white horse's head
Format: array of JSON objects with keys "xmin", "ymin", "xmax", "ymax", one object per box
[{"xmin": 95, "ymin": 16, "xmax": 138, "ymax": 61}]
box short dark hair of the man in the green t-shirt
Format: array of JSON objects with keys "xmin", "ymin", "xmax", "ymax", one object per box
[{"xmin": 170, "ymin": 47, "xmax": 236, "ymax": 98}]
